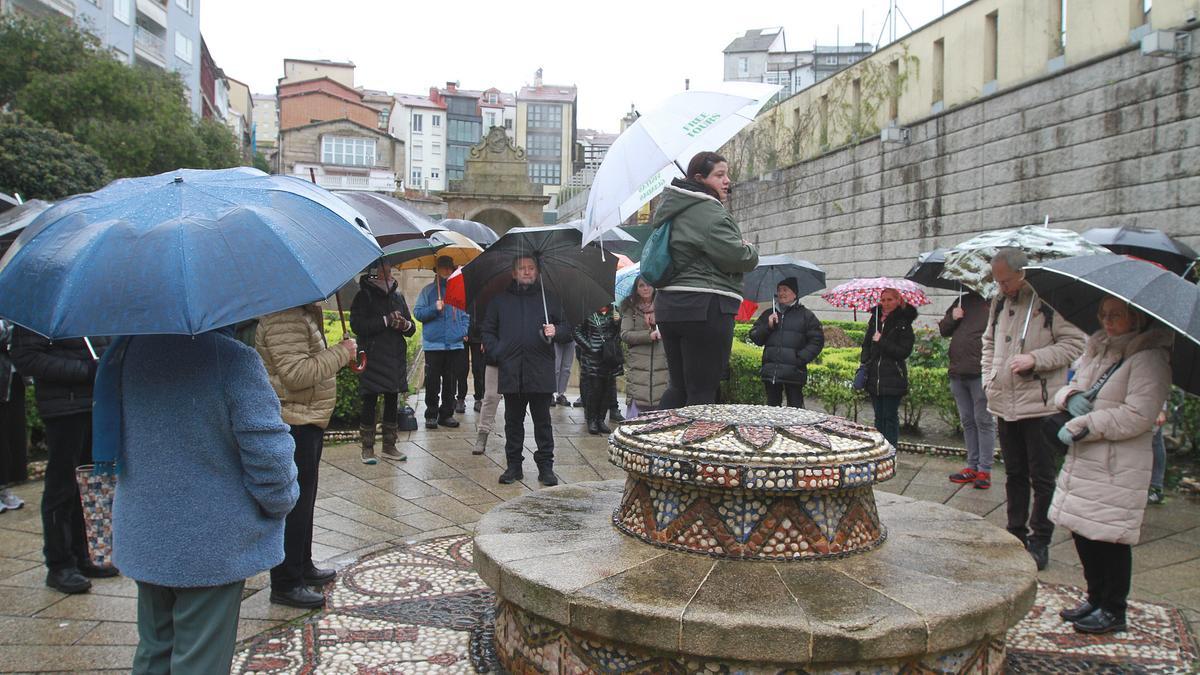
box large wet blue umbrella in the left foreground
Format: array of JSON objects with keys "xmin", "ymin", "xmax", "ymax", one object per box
[{"xmin": 0, "ymin": 167, "xmax": 380, "ymax": 339}]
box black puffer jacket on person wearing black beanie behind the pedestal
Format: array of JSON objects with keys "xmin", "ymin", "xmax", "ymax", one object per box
[{"xmin": 750, "ymin": 301, "xmax": 824, "ymax": 386}]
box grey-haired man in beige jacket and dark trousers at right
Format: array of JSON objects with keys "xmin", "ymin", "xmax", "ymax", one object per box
[{"xmin": 980, "ymin": 249, "xmax": 1087, "ymax": 569}]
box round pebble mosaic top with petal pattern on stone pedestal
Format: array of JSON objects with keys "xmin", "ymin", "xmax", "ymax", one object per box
[{"xmin": 608, "ymin": 405, "xmax": 895, "ymax": 492}]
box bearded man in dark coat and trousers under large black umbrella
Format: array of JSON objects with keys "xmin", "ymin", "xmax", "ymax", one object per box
[{"xmin": 482, "ymin": 256, "xmax": 571, "ymax": 486}]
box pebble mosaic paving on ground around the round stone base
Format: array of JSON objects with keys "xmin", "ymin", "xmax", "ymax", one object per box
[{"xmin": 233, "ymin": 536, "xmax": 1200, "ymax": 675}]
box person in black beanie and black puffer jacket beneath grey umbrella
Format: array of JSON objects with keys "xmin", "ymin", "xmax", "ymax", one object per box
[{"xmin": 750, "ymin": 276, "xmax": 824, "ymax": 408}]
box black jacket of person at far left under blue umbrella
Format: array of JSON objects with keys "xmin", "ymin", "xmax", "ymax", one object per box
[{"xmin": 11, "ymin": 327, "xmax": 109, "ymax": 419}]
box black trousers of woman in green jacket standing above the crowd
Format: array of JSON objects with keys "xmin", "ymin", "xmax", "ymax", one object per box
[{"xmin": 659, "ymin": 300, "xmax": 733, "ymax": 408}]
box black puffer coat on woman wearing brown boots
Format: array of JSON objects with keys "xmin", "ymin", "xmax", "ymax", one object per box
[{"xmin": 350, "ymin": 276, "xmax": 416, "ymax": 394}]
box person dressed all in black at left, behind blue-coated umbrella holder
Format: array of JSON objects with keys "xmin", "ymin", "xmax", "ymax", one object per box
[{"xmin": 12, "ymin": 328, "xmax": 116, "ymax": 593}]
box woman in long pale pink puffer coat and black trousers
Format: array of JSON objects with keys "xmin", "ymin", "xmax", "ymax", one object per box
[{"xmin": 1050, "ymin": 295, "xmax": 1174, "ymax": 633}]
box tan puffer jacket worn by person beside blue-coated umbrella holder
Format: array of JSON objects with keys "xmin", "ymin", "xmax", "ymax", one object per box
[{"xmin": 254, "ymin": 305, "xmax": 350, "ymax": 429}]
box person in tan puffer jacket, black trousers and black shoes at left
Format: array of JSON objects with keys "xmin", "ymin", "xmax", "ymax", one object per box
[{"xmin": 254, "ymin": 304, "xmax": 358, "ymax": 609}]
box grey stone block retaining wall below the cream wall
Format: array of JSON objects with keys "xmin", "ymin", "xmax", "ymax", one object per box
[{"xmin": 732, "ymin": 40, "xmax": 1200, "ymax": 321}]
